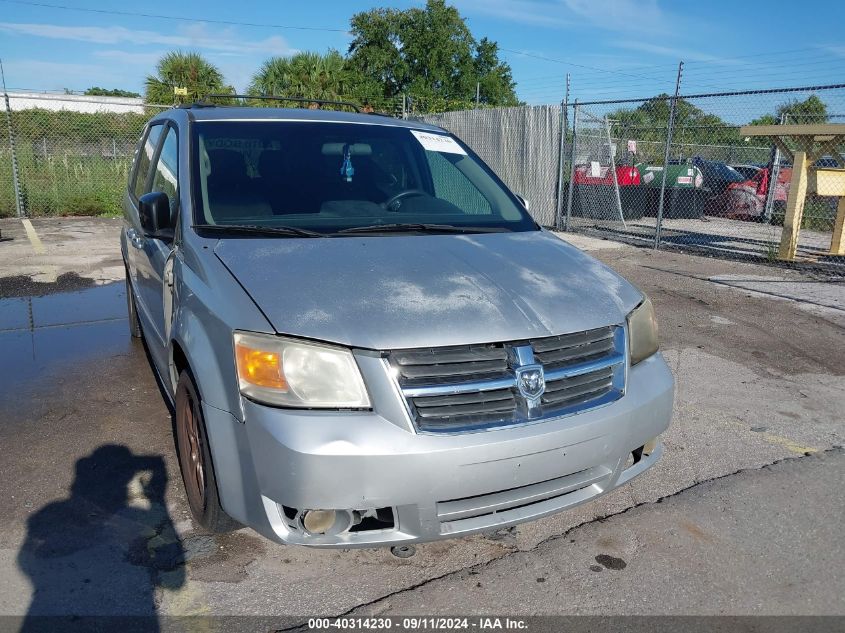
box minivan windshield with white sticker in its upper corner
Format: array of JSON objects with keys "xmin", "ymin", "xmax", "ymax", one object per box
[{"xmin": 193, "ymin": 121, "xmax": 537, "ymax": 234}]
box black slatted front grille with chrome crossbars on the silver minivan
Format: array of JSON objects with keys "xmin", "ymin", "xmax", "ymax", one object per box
[{"xmin": 387, "ymin": 326, "xmax": 626, "ymax": 433}]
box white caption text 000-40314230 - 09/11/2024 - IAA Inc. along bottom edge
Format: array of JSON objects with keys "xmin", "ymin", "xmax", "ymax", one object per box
[{"xmin": 308, "ymin": 616, "xmax": 528, "ymax": 631}]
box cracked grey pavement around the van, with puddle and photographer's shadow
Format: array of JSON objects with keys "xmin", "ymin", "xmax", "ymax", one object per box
[{"xmin": 0, "ymin": 218, "xmax": 845, "ymax": 617}]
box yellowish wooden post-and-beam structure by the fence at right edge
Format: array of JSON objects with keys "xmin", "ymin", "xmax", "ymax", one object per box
[{"xmin": 740, "ymin": 123, "xmax": 845, "ymax": 261}]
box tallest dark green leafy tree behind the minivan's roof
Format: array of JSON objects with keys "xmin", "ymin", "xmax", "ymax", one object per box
[{"xmin": 349, "ymin": 0, "xmax": 518, "ymax": 109}]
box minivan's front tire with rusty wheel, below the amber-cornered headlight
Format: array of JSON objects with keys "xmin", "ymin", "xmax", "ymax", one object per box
[{"xmin": 175, "ymin": 370, "xmax": 236, "ymax": 534}]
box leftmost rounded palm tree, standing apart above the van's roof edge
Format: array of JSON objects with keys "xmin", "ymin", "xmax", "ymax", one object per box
[{"xmin": 144, "ymin": 51, "xmax": 235, "ymax": 104}]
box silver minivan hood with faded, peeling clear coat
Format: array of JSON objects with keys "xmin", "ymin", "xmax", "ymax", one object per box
[{"xmin": 215, "ymin": 231, "xmax": 642, "ymax": 350}]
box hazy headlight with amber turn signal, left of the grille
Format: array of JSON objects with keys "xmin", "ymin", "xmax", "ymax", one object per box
[{"xmin": 235, "ymin": 332, "xmax": 370, "ymax": 409}]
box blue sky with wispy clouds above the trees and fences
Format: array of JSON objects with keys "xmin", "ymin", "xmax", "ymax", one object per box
[{"xmin": 0, "ymin": 0, "xmax": 845, "ymax": 104}]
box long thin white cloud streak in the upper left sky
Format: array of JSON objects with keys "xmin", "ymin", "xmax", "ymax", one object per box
[{"xmin": 0, "ymin": 22, "xmax": 294, "ymax": 55}]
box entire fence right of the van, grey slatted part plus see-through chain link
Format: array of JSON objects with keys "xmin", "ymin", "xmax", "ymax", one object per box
[{"xmin": 412, "ymin": 85, "xmax": 845, "ymax": 274}]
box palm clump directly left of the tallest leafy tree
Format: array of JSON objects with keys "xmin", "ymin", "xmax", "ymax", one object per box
[{"xmin": 248, "ymin": 50, "xmax": 353, "ymax": 106}]
